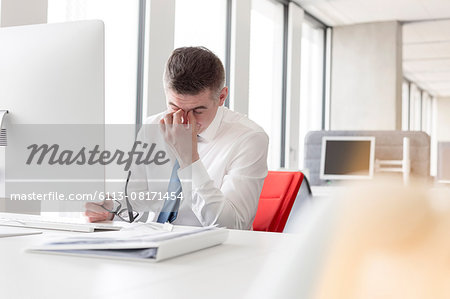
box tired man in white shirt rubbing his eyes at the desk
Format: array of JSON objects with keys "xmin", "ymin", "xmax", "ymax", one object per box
[{"xmin": 86, "ymin": 47, "xmax": 268, "ymax": 229}]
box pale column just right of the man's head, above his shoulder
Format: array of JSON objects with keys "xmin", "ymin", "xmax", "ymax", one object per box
[{"xmin": 230, "ymin": 0, "xmax": 252, "ymax": 114}]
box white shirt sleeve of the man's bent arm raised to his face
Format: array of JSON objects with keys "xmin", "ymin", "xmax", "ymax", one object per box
[{"xmin": 178, "ymin": 132, "xmax": 269, "ymax": 229}]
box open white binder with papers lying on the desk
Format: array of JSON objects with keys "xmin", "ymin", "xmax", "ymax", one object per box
[{"xmin": 28, "ymin": 224, "xmax": 228, "ymax": 261}]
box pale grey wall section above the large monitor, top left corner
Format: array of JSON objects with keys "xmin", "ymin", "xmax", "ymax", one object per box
[{"xmin": 0, "ymin": 0, "xmax": 48, "ymax": 27}]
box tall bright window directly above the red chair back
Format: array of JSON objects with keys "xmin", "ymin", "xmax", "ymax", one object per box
[{"xmin": 249, "ymin": 0, "xmax": 284, "ymax": 169}]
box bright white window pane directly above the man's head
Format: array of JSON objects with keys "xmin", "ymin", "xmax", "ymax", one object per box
[{"xmin": 174, "ymin": 0, "xmax": 227, "ymax": 66}]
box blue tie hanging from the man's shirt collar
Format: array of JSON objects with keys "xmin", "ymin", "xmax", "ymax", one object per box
[{"xmin": 156, "ymin": 161, "xmax": 181, "ymax": 223}]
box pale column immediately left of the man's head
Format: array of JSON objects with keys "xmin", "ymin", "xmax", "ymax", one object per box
[{"xmin": 143, "ymin": 0, "xmax": 175, "ymax": 119}]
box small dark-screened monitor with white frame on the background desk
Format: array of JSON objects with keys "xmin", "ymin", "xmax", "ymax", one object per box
[{"xmin": 320, "ymin": 136, "xmax": 375, "ymax": 180}]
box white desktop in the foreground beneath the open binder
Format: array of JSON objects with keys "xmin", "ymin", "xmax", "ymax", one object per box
[{"xmin": 0, "ymin": 230, "xmax": 312, "ymax": 298}]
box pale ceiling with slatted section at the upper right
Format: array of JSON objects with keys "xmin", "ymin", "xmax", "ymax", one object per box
[{"xmin": 295, "ymin": 0, "xmax": 450, "ymax": 97}]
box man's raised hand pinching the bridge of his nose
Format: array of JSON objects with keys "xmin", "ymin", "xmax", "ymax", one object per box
[{"xmin": 160, "ymin": 109, "xmax": 199, "ymax": 168}]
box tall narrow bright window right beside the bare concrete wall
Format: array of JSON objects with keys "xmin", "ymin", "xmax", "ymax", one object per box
[{"xmin": 299, "ymin": 16, "xmax": 326, "ymax": 169}]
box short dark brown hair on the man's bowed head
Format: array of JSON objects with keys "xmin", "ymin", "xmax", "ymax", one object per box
[{"xmin": 164, "ymin": 47, "xmax": 225, "ymax": 95}]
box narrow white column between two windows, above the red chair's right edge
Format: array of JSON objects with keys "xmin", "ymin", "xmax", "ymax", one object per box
[{"xmin": 286, "ymin": 2, "xmax": 304, "ymax": 169}]
